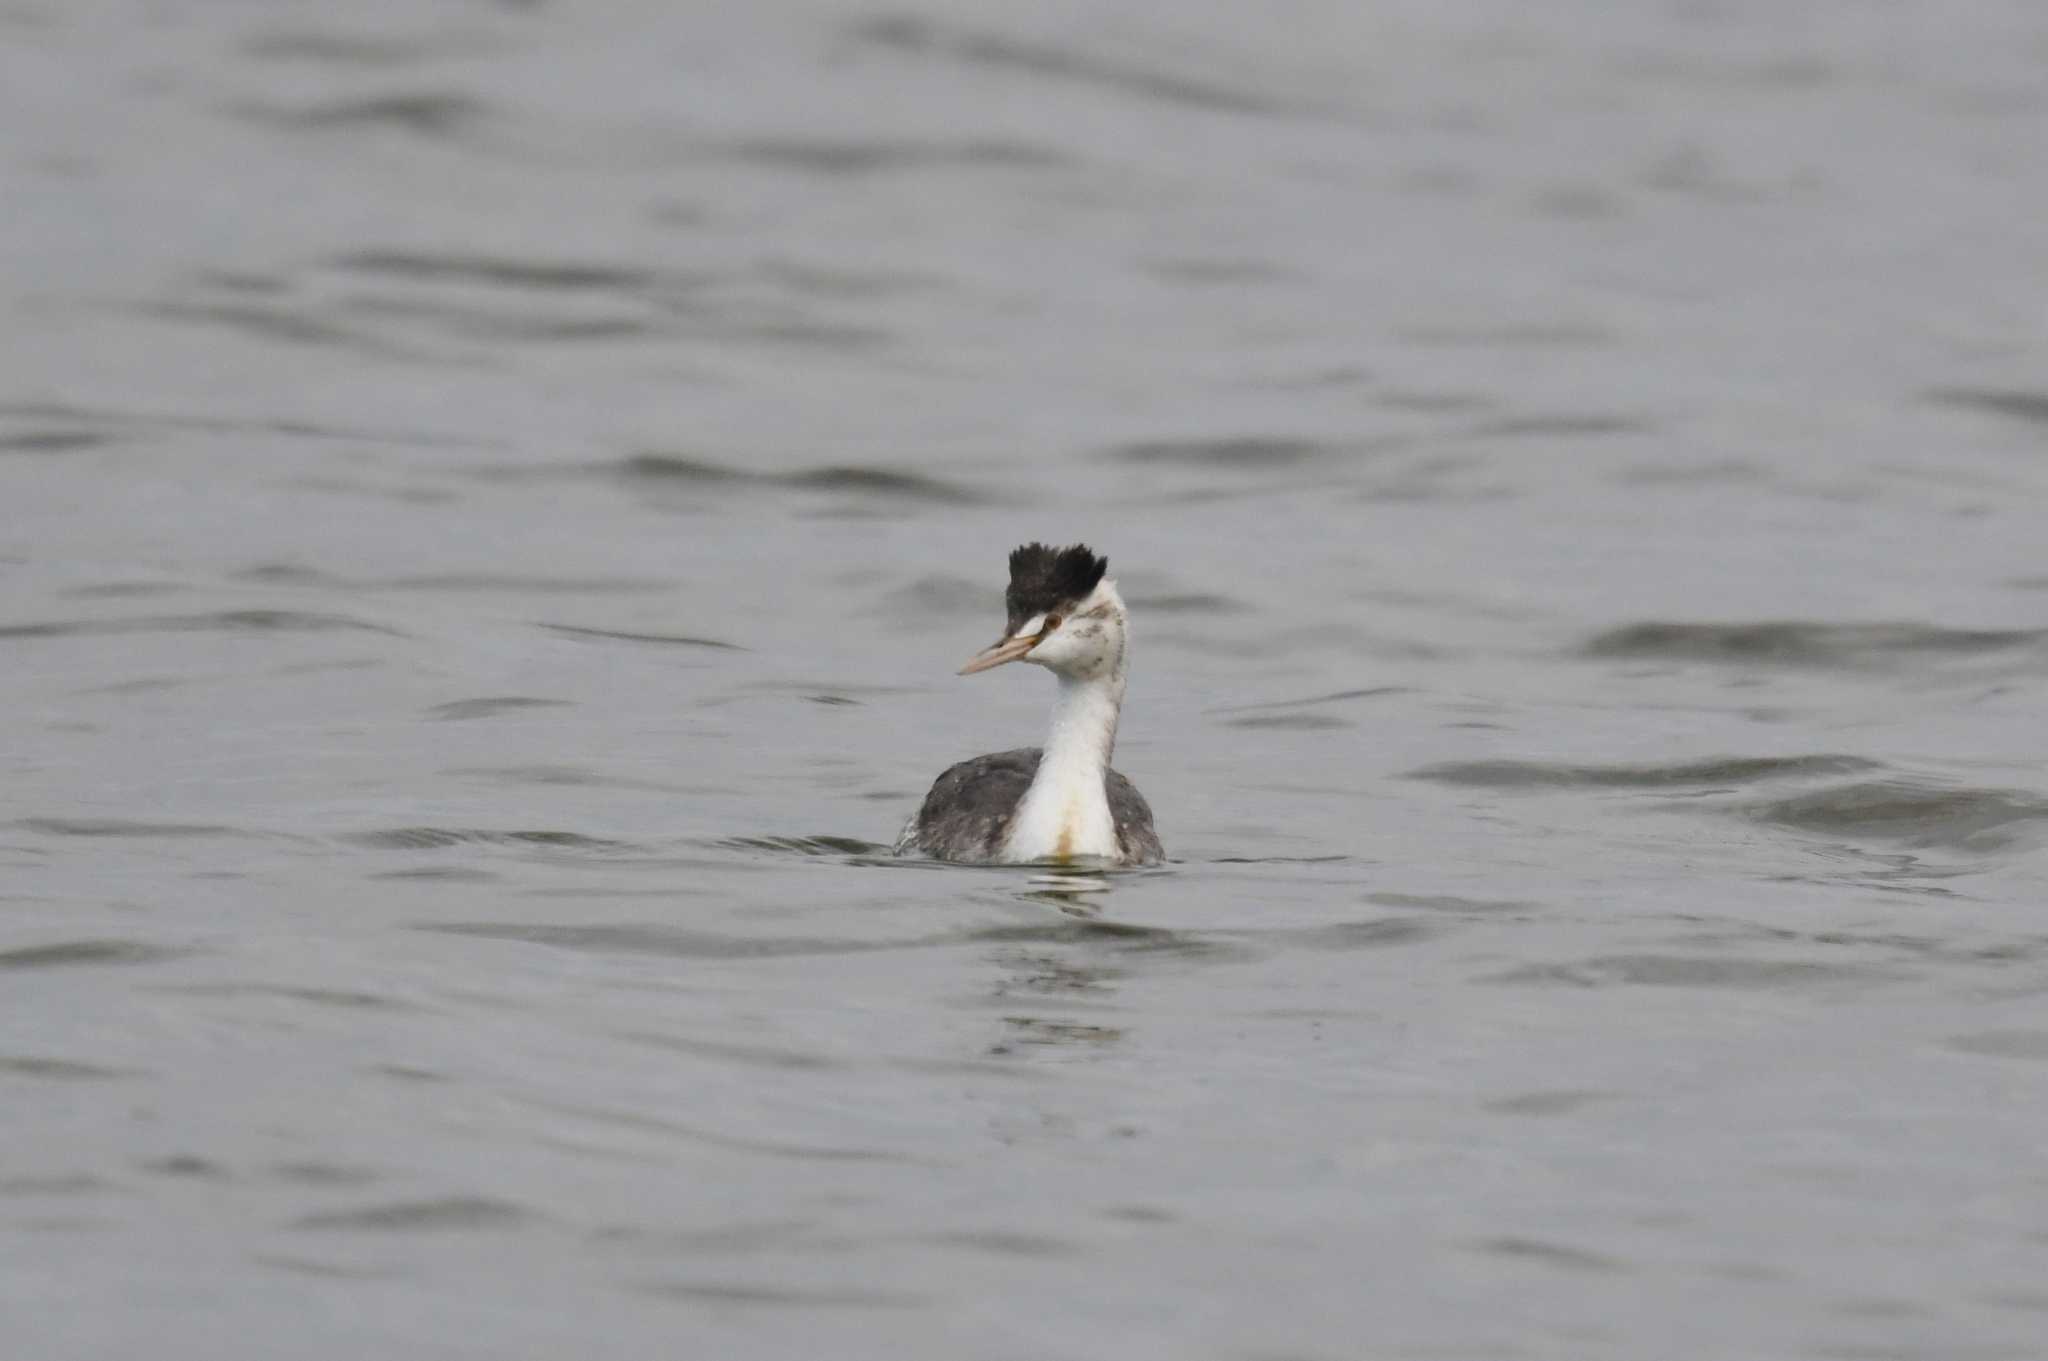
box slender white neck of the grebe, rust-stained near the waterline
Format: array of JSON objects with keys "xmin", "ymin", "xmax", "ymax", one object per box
[{"xmin": 1004, "ymin": 657, "xmax": 1124, "ymax": 862}]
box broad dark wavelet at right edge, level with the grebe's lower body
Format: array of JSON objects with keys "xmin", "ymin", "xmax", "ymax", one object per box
[{"xmin": 1741, "ymin": 780, "xmax": 2048, "ymax": 849}]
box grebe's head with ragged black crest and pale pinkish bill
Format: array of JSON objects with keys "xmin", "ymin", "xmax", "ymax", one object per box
[{"xmin": 961, "ymin": 544, "xmax": 1124, "ymax": 679}]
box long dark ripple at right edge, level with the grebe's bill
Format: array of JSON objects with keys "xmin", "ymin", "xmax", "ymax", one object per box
[{"xmin": 1579, "ymin": 620, "xmax": 2048, "ymax": 667}]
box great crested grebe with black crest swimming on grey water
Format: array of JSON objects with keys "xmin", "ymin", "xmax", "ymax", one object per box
[{"xmin": 895, "ymin": 544, "xmax": 1165, "ymax": 866}]
